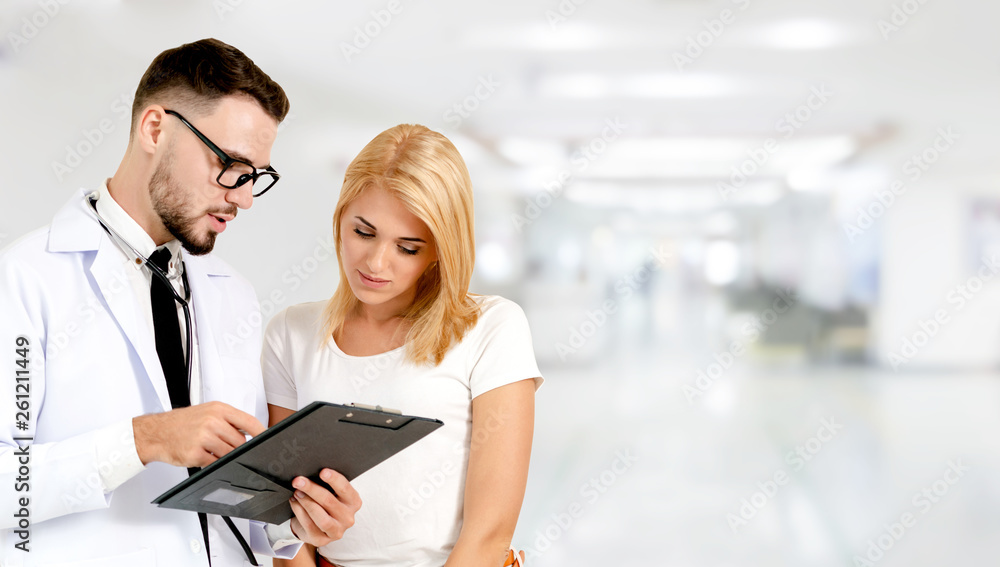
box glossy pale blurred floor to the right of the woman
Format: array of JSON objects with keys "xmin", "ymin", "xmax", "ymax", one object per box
[{"xmin": 515, "ymin": 349, "xmax": 1000, "ymax": 567}]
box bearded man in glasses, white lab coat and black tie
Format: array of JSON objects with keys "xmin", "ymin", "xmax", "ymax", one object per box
[{"xmin": 0, "ymin": 39, "xmax": 361, "ymax": 567}]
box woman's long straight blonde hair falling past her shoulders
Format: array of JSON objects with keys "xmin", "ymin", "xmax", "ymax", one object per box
[{"xmin": 322, "ymin": 124, "xmax": 479, "ymax": 365}]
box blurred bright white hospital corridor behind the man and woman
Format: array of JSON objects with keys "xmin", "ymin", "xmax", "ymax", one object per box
[{"xmin": 0, "ymin": 0, "xmax": 1000, "ymax": 567}]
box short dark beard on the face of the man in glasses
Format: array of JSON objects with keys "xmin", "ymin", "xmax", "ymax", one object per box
[{"xmin": 149, "ymin": 150, "xmax": 236, "ymax": 256}]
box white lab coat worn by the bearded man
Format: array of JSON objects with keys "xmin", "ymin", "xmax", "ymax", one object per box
[{"xmin": 0, "ymin": 192, "xmax": 271, "ymax": 567}]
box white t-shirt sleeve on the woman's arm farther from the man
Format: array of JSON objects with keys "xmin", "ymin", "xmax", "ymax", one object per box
[{"xmin": 469, "ymin": 299, "xmax": 543, "ymax": 398}]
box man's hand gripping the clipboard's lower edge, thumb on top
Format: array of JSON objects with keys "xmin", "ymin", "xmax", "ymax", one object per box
[{"xmin": 291, "ymin": 469, "xmax": 361, "ymax": 547}]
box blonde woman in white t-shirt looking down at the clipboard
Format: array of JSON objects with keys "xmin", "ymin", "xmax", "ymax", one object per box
[{"xmin": 263, "ymin": 124, "xmax": 542, "ymax": 567}]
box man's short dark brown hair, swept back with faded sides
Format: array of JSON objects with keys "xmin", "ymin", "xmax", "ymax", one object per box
[{"xmin": 132, "ymin": 38, "xmax": 288, "ymax": 131}]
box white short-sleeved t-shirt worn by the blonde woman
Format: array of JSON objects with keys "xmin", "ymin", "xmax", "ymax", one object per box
[{"xmin": 262, "ymin": 296, "xmax": 542, "ymax": 567}]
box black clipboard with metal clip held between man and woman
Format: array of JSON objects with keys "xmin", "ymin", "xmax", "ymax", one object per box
[{"xmin": 152, "ymin": 402, "xmax": 444, "ymax": 524}]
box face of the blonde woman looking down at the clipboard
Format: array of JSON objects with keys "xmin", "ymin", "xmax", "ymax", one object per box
[{"xmin": 340, "ymin": 187, "xmax": 437, "ymax": 318}]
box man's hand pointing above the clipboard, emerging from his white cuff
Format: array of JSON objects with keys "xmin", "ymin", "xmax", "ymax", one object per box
[{"xmin": 132, "ymin": 402, "xmax": 266, "ymax": 467}]
